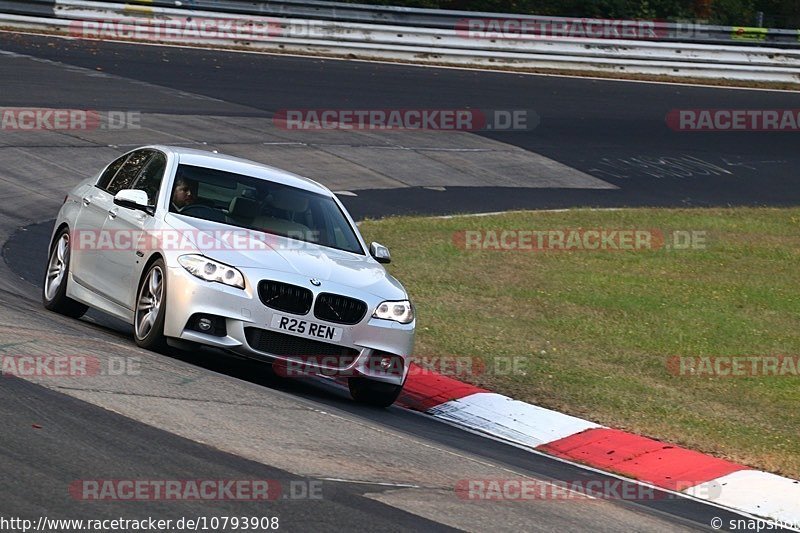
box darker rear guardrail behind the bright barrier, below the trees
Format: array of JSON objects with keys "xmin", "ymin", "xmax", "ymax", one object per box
[{"xmin": 79, "ymin": 0, "xmax": 800, "ymax": 48}]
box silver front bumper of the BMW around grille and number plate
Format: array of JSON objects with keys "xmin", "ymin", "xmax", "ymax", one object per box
[{"xmin": 164, "ymin": 266, "xmax": 415, "ymax": 385}]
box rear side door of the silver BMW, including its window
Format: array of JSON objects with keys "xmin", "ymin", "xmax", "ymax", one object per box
[{"xmin": 70, "ymin": 154, "xmax": 130, "ymax": 291}]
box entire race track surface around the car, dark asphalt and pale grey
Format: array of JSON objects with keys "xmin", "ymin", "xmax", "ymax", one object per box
[{"xmin": 0, "ymin": 33, "xmax": 800, "ymax": 531}]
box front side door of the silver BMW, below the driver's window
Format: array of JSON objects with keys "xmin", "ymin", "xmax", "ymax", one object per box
[{"xmin": 93, "ymin": 149, "xmax": 154, "ymax": 308}]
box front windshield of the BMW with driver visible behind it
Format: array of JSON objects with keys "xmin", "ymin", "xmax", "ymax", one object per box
[{"xmin": 170, "ymin": 165, "xmax": 364, "ymax": 255}]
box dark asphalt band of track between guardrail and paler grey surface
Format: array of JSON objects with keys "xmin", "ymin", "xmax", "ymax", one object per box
[{"xmin": 0, "ymin": 36, "xmax": 800, "ymax": 215}]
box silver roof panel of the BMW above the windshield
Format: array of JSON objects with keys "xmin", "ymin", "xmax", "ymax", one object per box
[{"xmin": 146, "ymin": 145, "xmax": 333, "ymax": 196}]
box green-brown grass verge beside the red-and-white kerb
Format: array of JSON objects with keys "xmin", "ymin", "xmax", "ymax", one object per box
[{"xmin": 361, "ymin": 208, "xmax": 800, "ymax": 478}]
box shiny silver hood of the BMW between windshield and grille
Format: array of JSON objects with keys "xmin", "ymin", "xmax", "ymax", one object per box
[{"xmin": 165, "ymin": 213, "xmax": 407, "ymax": 300}]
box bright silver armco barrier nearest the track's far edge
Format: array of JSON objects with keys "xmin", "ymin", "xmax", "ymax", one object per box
[{"xmin": 0, "ymin": 0, "xmax": 800, "ymax": 82}]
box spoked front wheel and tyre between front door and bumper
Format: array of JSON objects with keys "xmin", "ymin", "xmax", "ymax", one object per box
[{"xmin": 133, "ymin": 258, "xmax": 167, "ymax": 351}]
